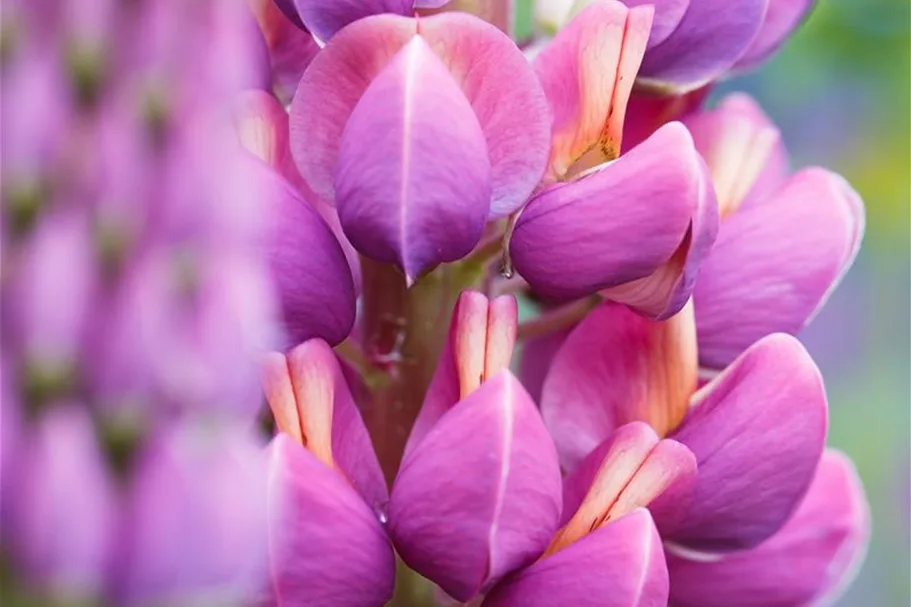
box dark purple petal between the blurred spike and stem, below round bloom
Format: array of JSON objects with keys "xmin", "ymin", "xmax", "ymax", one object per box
[{"xmin": 262, "ymin": 171, "xmax": 355, "ymax": 344}]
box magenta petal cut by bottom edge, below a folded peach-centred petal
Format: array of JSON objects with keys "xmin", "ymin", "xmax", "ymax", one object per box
[{"xmin": 483, "ymin": 509, "xmax": 668, "ymax": 607}]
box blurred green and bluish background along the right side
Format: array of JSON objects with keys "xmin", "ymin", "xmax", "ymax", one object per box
[{"xmin": 716, "ymin": 0, "xmax": 911, "ymax": 607}]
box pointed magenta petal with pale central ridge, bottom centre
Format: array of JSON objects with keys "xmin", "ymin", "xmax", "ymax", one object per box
[{"xmin": 389, "ymin": 371, "xmax": 561, "ymax": 602}]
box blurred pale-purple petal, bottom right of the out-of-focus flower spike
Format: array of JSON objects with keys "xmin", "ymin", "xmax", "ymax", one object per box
[{"xmin": 115, "ymin": 422, "xmax": 268, "ymax": 605}]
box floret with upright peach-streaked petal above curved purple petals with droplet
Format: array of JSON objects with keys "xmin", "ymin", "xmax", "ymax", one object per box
[{"xmin": 509, "ymin": 2, "xmax": 718, "ymax": 318}]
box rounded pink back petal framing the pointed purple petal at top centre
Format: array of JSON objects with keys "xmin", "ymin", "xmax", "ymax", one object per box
[{"xmin": 291, "ymin": 12, "xmax": 550, "ymax": 217}]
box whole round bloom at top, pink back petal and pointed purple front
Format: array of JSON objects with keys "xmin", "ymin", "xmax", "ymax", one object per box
[{"xmin": 290, "ymin": 13, "xmax": 550, "ymax": 282}]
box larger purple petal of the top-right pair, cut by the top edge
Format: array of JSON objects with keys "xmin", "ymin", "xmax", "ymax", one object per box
[{"xmin": 639, "ymin": 0, "xmax": 769, "ymax": 93}]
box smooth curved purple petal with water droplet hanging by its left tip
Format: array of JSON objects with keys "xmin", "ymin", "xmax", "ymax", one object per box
[{"xmin": 509, "ymin": 123, "xmax": 705, "ymax": 300}]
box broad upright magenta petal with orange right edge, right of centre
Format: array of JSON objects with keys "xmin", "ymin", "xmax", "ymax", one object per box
[{"xmin": 541, "ymin": 303, "xmax": 697, "ymax": 469}]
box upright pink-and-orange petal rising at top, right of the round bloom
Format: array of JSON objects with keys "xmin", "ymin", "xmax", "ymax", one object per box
[{"xmin": 533, "ymin": 1, "xmax": 653, "ymax": 183}]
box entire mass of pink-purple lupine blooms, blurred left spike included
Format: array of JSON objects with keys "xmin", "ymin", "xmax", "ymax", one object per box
[{"xmin": 2, "ymin": 0, "xmax": 869, "ymax": 607}]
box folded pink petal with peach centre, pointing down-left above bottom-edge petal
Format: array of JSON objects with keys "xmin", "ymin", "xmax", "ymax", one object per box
[{"xmin": 547, "ymin": 422, "xmax": 696, "ymax": 554}]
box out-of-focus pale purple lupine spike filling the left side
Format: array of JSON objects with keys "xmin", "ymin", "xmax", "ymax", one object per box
[{"xmin": 0, "ymin": 0, "xmax": 277, "ymax": 606}]
